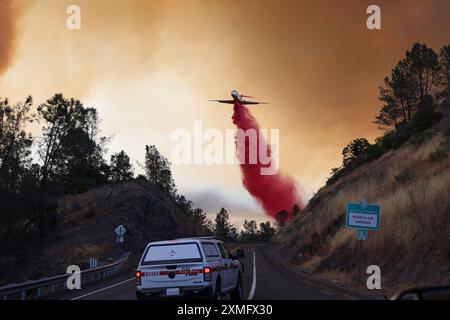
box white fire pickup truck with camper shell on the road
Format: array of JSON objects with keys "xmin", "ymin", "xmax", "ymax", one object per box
[{"xmin": 136, "ymin": 237, "xmax": 244, "ymax": 300}]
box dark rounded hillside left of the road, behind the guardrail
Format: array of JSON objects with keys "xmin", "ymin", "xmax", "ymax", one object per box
[{"xmin": 0, "ymin": 181, "xmax": 207, "ymax": 285}]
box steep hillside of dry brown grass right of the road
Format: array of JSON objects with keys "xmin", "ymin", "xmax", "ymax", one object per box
[{"xmin": 272, "ymin": 100, "xmax": 450, "ymax": 293}]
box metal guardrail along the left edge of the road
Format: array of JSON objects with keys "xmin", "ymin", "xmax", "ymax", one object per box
[{"xmin": 0, "ymin": 253, "xmax": 130, "ymax": 300}]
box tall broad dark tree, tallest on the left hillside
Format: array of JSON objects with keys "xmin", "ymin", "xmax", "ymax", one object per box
[{"xmin": 35, "ymin": 94, "xmax": 107, "ymax": 236}]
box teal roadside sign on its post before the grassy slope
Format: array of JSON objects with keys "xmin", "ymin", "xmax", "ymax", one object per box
[{"xmin": 346, "ymin": 200, "xmax": 381, "ymax": 282}]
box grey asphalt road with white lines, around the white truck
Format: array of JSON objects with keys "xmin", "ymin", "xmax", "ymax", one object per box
[{"xmin": 53, "ymin": 244, "xmax": 367, "ymax": 300}]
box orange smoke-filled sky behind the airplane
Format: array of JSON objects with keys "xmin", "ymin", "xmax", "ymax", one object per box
[{"xmin": 0, "ymin": 0, "xmax": 450, "ymax": 225}]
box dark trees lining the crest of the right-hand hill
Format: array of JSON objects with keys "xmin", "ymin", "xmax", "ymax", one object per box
[{"xmin": 327, "ymin": 43, "xmax": 450, "ymax": 184}]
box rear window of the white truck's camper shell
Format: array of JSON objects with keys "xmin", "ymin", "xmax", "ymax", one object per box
[{"xmin": 142, "ymin": 242, "xmax": 203, "ymax": 265}]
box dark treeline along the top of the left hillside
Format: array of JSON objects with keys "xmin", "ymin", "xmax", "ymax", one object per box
[{"xmin": 0, "ymin": 94, "xmax": 206, "ymax": 252}]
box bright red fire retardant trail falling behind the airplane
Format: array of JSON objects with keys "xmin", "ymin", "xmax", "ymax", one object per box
[{"xmin": 232, "ymin": 102, "xmax": 304, "ymax": 220}]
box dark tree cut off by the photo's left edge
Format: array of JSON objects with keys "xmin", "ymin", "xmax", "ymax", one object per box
[{"xmin": 0, "ymin": 97, "xmax": 36, "ymax": 251}]
